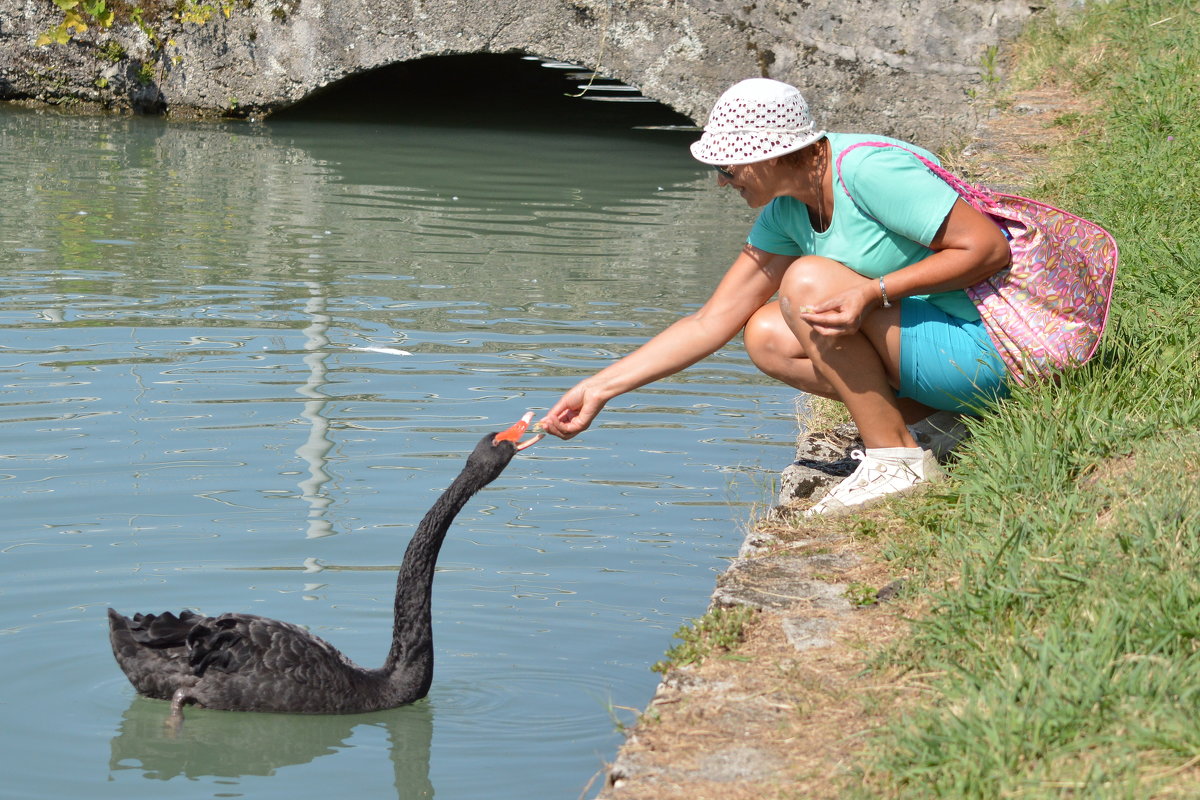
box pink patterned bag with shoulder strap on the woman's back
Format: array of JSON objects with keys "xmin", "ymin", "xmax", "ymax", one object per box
[{"xmin": 836, "ymin": 142, "xmax": 1117, "ymax": 384}]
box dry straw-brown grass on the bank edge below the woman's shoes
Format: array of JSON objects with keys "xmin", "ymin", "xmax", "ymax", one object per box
[{"xmin": 604, "ymin": 494, "xmax": 945, "ymax": 800}]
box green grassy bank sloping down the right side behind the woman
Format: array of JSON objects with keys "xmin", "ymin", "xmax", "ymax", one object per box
[{"xmin": 825, "ymin": 0, "xmax": 1200, "ymax": 800}]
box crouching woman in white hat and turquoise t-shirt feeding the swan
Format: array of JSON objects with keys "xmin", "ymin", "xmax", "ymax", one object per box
[{"xmin": 541, "ymin": 78, "xmax": 1009, "ymax": 513}]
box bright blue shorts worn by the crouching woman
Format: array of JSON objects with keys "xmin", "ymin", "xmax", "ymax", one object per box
[{"xmin": 896, "ymin": 297, "xmax": 1008, "ymax": 414}]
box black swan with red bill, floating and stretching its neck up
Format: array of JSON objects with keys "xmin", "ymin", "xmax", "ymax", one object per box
[{"xmin": 108, "ymin": 411, "xmax": 541, "ymax": 723}]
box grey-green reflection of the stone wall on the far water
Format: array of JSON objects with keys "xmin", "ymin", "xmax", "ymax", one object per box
[{"xmin": 0, "ymin": 103, "xmax": 750, "ymax": 327}]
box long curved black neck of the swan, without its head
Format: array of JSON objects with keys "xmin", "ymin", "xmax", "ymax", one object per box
[{"xmin": 380, "ymin": 462, "xmax": 494, "ymax": 697}]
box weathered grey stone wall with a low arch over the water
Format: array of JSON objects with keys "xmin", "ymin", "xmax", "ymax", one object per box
[{"xmin": 0, "ymin": 0, "xmax": 1031, "ymax": 145}]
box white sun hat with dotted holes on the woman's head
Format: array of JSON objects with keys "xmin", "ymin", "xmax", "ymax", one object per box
[{"xmin": 691, "ymin": 78, "xmax": 826, "ymax": 166}]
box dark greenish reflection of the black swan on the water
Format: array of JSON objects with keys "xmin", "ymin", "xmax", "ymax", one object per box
[{"xmin": 108, "ymin": 696, "xmax": 433, "ymax": 800}]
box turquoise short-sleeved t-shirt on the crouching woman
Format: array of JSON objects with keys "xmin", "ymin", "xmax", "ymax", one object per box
[{"xmin": 748, "ymin": 133, "xmax": 979, "ymax": 320}]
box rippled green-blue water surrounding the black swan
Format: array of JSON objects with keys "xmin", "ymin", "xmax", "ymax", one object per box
[{"xmin": 0, "ymin": 70, "xmax": 794, "ymax": 800}]
